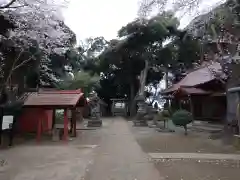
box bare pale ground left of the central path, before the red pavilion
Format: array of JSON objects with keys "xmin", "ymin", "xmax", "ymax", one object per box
[{"xmin": 0, "ymin": 119, "xmax": 108, "ymax": 180}]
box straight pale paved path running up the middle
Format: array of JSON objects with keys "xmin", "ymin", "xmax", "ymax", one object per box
[{"xmin": 85, "ymin": 118, "xmax": 163, "ymax": 180}]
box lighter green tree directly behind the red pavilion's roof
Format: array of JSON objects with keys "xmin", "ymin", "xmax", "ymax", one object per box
[{"xmin": 52, "ymin": 37, "xmax": 108, "ymax": 96}]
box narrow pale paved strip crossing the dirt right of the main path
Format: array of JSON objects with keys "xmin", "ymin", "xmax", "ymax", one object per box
[{"xmin": 149, "ymin": 153, "xmax": 240, "ymax": 160}]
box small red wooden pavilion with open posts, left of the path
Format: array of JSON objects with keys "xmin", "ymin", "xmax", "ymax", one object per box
[{"xmin": 19, "ymin": 89, "xmax": 84, "ymax": 141}]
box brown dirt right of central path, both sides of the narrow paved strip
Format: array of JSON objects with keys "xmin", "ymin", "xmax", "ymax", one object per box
[{"xmin": 132, "ymin": 123, "xmax": 240, "ymax": 180}]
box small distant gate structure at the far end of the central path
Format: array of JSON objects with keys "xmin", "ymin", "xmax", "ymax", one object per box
[{"xmin": 111, "ymin": 99, "xmax": 128, "ymax": 116}]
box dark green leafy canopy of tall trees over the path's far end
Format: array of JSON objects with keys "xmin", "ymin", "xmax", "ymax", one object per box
[{"xmin": 84, "ymin": 12, "xmax": 200, "ymax": 114}]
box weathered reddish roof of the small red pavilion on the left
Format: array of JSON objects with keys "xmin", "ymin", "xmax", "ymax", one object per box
[{"xmin": 24, "ymin": 90, "xmax": 83, "ymax": 107}]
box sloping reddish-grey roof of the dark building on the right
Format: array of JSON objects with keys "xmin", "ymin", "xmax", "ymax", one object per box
[{"xmin": 162, "ymin": 62, "xmax": 221, "ymax": 93}]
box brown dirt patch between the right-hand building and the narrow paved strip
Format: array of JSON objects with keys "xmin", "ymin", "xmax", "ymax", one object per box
[{"xmin": 132, "ymin": 124, "xmax": 239, "ymax": 153}]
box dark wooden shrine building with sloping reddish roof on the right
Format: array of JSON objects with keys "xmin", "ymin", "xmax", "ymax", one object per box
[{"xmin": 162, "ymin": 63, "xmax": 226, "ymax": 121}]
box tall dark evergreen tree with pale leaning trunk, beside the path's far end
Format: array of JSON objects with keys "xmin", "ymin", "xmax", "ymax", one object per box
[{"xmin": 93, "ymin": 12, "xmax": 200, "ymax": 116}]
